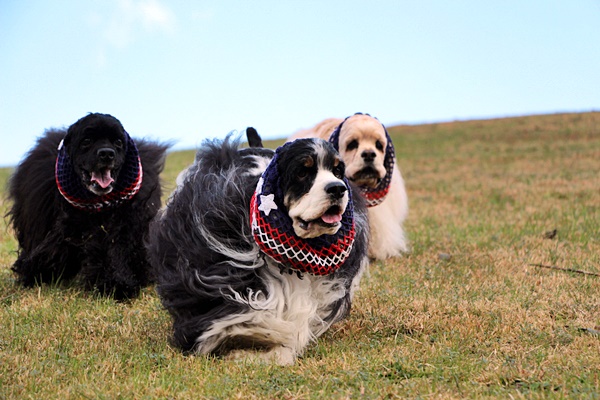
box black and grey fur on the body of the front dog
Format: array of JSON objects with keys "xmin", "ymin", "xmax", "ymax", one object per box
[{"xmin": 148, "ymin": 137, "xmax": 368, "ymax": 353}]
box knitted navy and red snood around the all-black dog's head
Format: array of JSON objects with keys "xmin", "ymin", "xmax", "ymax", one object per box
[{"xmin": 54, "ymin": 133, "xmax": 144, "ymax": 212}]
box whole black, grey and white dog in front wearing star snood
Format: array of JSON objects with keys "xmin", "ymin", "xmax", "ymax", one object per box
[{"xmin": 149, "ymin": 128, "xmax": 368, "ymax": 365}]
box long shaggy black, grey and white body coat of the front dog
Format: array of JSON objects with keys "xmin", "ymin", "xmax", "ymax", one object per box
[{"xmin": 148, "ymin": 138, "xmax": 368, "ymax": 364}]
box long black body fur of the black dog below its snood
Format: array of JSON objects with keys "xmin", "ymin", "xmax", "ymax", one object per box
[{"xmin": 8, "ymin": 115, "xmax": 168, "ymax": 299}]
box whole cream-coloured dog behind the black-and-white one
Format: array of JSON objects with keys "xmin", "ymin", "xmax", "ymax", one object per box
[{"xmin": 289, "ymin": 113, "xmax": 408, "ymax": 259}]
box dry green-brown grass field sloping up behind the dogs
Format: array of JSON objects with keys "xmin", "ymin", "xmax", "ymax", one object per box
[{"xmin": 0, "ymin": 113, "xmax": 600, "ymax": 399}]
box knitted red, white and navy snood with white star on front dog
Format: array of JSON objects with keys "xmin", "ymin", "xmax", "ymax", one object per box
[{"xmin": 250, "ymin": 144, "xmax": 355, "ymax": 275}]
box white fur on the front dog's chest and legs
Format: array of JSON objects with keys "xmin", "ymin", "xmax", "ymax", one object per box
[{"xmin": 197, "ymin": 259, "xmax": 367, "ymax": 365}]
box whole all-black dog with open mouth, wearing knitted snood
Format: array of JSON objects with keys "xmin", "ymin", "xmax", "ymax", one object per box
[{"xmin": 8, "ymin": 113, "xmax": 168, "ymax": 299}]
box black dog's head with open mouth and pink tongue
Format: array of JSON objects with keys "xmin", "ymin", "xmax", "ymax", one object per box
[{"xmin": 62, "ymin": 114, "xmax": 129, "ymax": 196}]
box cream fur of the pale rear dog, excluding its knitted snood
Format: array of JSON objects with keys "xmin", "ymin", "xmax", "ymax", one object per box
[{"xmin": 288, "ymin": 114, "xmax": 408, "ymax": 259}]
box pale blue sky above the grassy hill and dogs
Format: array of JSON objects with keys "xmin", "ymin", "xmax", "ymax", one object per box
[{"xmin": 0, "ymin": 0, "xmax": 600, "ymax": 165}]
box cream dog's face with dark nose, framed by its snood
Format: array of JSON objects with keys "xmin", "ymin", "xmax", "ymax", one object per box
[{"xmin": 338, "ymin": 114, "xmax": 388, "ymax": 188}]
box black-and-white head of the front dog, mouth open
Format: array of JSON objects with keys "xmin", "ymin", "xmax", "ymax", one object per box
[{"xmin": 276, "ymin": 139, "xmax": 349, "ymax": 239}]
